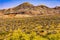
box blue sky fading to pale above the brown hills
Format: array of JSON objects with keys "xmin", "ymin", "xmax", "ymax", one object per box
[{"xmin": 0, "ymin": 0, "xmax": 60, "ymax": 9}]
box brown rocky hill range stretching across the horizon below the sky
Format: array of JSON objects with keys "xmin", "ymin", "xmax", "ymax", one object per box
[{"xmin": 0, "ymin": 2, "xmax": 60, "ymax": 15}]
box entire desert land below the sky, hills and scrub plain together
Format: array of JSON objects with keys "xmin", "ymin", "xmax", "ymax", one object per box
[{"xmin": 0, "ymin": 2, "xmax": 60, "ymax": 40}]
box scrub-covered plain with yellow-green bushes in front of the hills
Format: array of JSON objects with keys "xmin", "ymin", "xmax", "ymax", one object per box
[{"xmin": 0, "ymin": 16, "xmax": 60, "ymax": 40}]
